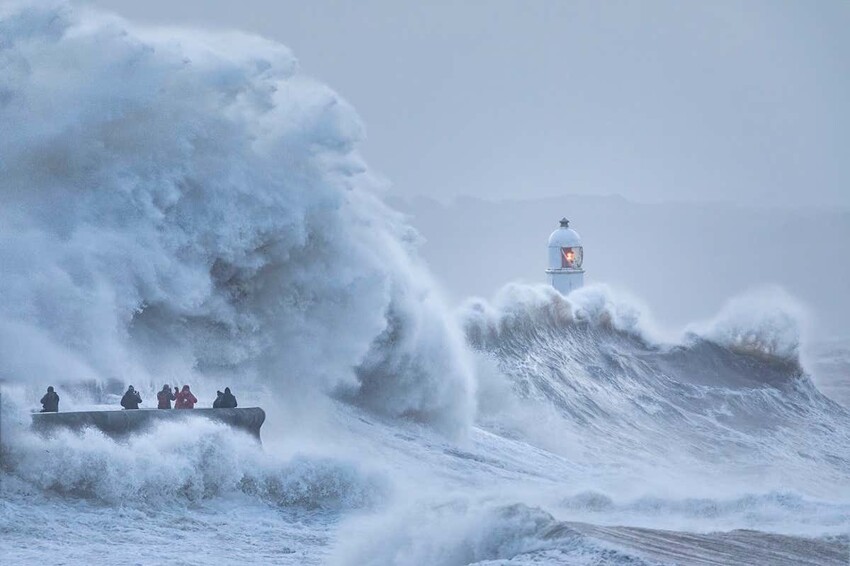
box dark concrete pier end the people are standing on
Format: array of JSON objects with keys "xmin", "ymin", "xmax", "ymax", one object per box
[{"xmin": 32, "ymin": 407, "xmax": 266, "ymax": 441}]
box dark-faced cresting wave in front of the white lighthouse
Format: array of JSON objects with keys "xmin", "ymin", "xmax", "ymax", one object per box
[{"xmin": 460, "ymin": 285, "xmax": 850, "ymax": 498}]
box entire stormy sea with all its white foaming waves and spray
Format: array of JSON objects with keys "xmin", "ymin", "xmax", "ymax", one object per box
[{"xmin": 0, "ymin": 3, "xmax": 850, "ymax": 565}]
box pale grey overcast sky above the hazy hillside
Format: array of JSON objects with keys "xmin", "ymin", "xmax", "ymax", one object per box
[{"xmin": 90, "ymin": 0, "xmax": 850, "ymax": 207}]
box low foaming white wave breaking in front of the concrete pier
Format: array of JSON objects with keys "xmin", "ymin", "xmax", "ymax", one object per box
[{"xmin": 0, "ymin": 414, "xmax": 389, "ymax": 511}]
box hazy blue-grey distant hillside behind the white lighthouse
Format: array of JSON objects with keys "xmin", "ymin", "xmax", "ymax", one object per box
[{"xmin": 390, "ymin": 196, "xmax": 850, "ymax": 342}]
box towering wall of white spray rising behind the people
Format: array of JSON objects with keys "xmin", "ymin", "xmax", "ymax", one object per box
[{"xmin": 0, "ymin": 2, "xmax": 474, "ymax": 434}]
